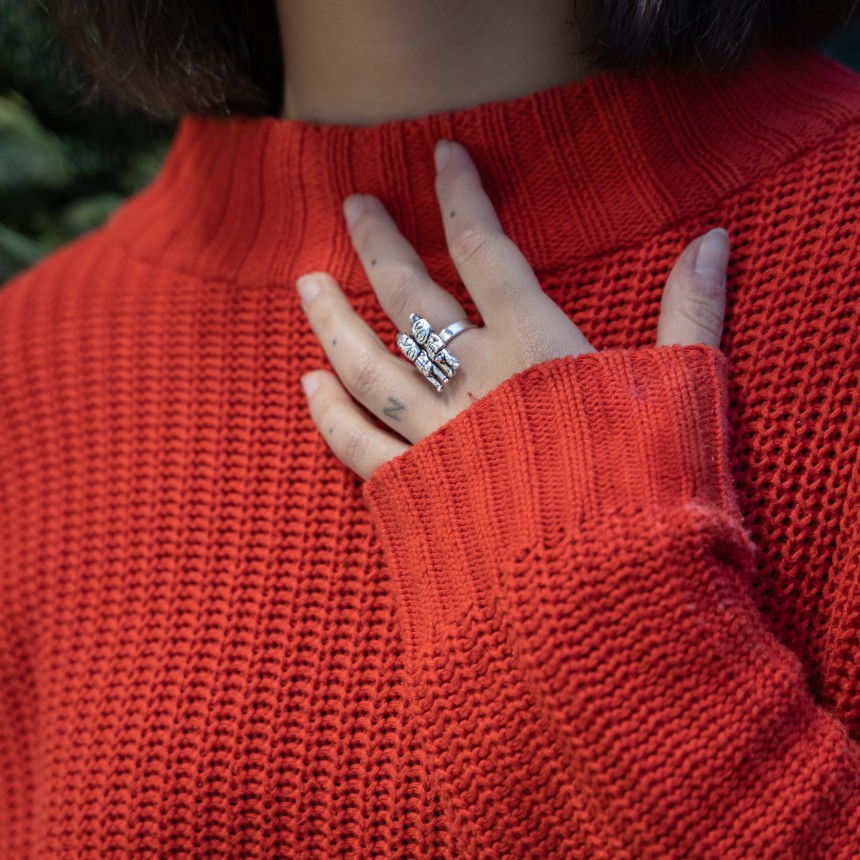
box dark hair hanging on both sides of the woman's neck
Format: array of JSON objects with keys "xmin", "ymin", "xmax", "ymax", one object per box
[{"xmin": 38, "ymin": 0, "xmax": 858, "ymax": 115}]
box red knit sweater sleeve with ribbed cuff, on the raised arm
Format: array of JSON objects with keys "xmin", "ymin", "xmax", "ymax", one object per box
[{"xmin": 364, "ymin": 345, "xmax": 860, "ymax": 860}]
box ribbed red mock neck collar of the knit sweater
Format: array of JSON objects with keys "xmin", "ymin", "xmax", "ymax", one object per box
[{"xmin": 108, "ymin": 45, "xmax": 857, "ymax": 285}]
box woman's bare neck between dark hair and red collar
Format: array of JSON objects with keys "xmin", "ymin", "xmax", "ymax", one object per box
[{"xmin": 277, "ymin": 0, "xmax": 597, "ymax": 126}]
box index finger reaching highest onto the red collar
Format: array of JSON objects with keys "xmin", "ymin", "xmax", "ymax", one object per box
[{"xmin": 436, "ymin": 141, "xmax": 544, "ymax": 327}]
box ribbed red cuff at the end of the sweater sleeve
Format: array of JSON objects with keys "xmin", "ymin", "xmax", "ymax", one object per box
[{"xmin": 362, "ymin": 344, "xmax": 740, "ymax": 636}]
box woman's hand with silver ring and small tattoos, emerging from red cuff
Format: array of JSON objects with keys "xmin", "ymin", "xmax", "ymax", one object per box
[{"xmin": 297, "ymin": 141, "xmax": 729, "ymax": 479}]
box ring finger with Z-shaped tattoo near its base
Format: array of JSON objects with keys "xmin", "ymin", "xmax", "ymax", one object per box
[{"xmin": 296, "ymin": 272, "xmax": 446, "ymax": 442}]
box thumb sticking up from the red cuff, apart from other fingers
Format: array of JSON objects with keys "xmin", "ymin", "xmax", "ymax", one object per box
[{"xmin": 657, "ymin": 227, "xmax": 730, "ymax": 349}]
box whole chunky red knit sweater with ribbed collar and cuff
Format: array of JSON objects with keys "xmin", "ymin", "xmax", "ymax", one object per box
[{"xmin": 0, "ymin": 40, "xmax": 860, "ymax": 860}]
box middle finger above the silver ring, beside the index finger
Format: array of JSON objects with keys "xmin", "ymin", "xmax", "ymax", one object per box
[{"xmin": 343, "ymin": 194, "xmax": 466, "ymax": 334}]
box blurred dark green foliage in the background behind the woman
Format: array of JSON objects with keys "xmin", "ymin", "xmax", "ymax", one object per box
[{"xmin": 0, "ymin": 0, "xmax": 860, "ymax": 283}]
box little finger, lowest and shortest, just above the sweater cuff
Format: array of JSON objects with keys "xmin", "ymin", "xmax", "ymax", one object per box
[{"xmin": 302, "ymin": 370, "xmax": 411, "ymax": 481}]
